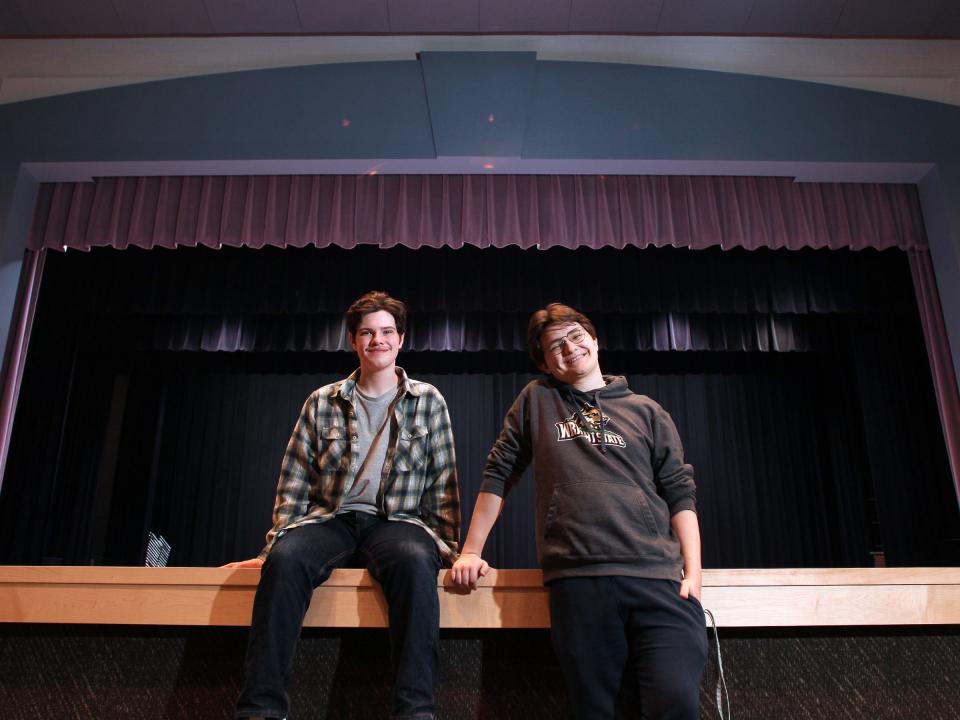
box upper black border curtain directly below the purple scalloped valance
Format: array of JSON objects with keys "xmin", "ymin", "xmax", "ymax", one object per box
[{"xmin": 37, "ymin": 247, "xmax": 913, "ymax": 316}]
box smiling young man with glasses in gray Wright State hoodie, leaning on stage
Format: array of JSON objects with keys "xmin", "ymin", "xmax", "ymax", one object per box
[{"xmin": 452, "ymin": 303, "xmax": 707, "ymax": 720}]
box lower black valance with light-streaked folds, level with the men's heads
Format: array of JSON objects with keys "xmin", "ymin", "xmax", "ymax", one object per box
[{"xmin": 84, "ymin": 312, "xmax": 843, "ymax": 353}]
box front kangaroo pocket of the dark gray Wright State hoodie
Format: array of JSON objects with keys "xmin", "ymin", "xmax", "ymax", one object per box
[{"xmin": 541, "ymin": 480, "xmax": 663, "ymax": 563}]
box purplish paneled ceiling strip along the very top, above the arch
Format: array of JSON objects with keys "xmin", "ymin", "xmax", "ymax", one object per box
[{"xmin": 0, "ymin": 0, "xmax": 960, "ymax": 38}]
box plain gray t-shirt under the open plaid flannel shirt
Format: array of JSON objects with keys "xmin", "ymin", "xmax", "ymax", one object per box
[{"xmin": 340, "ymin": 387, "xmax": 397, "ymax": 515}]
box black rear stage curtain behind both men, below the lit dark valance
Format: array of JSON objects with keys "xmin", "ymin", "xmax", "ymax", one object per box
[{"xmin": 0, "ymin": 353, "xmax": 958, "ymax": 567}]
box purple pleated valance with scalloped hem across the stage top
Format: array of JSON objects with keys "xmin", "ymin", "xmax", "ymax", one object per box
[{"xmin": 29, "ymin": 175, "xmax": 926, "ymax": 250}]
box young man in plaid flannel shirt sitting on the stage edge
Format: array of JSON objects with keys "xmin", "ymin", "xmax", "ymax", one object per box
[{"xmin": 230, "ymin": 292, "xmax": 460, "ymax": 719}]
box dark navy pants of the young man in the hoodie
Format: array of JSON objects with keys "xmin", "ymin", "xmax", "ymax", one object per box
[{"xmin": 550, "ymin": 576, "xmax": 707, "ymax": 720}]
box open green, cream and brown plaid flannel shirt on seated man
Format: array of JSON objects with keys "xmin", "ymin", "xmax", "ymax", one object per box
[{"xmin": 260, "ymin": 367, "xmax": 460, "ymax": 562}]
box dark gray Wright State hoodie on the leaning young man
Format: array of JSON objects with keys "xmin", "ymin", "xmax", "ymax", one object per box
[{"xmin": 480, "ymin": 376, "xmax": 696, "ymax": 582}]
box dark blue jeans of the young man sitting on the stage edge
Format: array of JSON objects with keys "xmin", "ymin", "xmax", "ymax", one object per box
[{"xmin": 237, "ymin": 512, "xmax": 440, "ymax": 718}]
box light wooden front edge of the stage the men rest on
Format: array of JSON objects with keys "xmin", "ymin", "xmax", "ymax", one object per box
[{"xmin": 0, "ymin": 566, "xmax": 960, "ymax": 629}]
